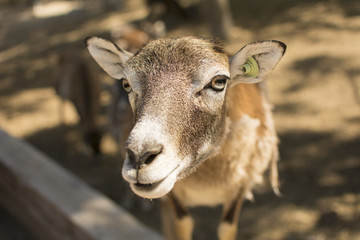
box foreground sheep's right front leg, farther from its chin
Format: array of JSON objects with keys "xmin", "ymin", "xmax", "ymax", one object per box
[{"xmin": 218, "ymin": 188, "xmax": 246, "ymax": 240}]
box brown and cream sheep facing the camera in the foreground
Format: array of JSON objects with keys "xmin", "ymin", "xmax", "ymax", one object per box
[{"xmin": 86, "ymin": 37, "xmax": 286, "ymax": 240}]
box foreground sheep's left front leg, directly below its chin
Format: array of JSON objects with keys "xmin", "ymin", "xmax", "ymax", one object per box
[{"xmin": 161, "ymin": 193, "xmax": 194, "ymax": 240}]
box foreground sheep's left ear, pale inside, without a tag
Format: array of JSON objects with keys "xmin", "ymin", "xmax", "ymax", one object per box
[{"xmin": 85, "ymin": 37, "xmax": 133, "ymax": 79}]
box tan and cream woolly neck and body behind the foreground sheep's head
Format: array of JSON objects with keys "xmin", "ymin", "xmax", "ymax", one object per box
[{"xmin": 165, "ymin": 84, "xmax": 278, "ymax": 239}]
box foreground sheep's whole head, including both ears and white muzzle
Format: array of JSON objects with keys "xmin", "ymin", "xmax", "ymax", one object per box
[{"xmin": 87, "ymin": 37, "xmax": 284, "ymax": 198}]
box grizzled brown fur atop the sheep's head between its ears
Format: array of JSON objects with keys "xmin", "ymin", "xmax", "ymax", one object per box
[{"xmin": 127, "ymin": 37, "xmax": 228, "ymax": 77}]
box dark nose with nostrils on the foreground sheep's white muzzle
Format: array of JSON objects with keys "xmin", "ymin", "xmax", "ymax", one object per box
[{"xmin": 126, "ymin": 143, "xmax": 163, "ymax": 169}]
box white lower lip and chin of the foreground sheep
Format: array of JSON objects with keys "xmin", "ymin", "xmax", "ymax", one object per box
[{"xmin": 130, "ymin": 167, "xmax": 178, "ymax": 199}]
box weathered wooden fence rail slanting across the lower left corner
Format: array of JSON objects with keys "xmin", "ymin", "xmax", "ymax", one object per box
[{"xmin": 0, "ymin": 130, "xmax": 162, "ymax": 240}]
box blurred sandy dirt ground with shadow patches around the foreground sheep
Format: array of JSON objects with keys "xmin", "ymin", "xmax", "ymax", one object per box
[{"xmin": 0, "ymin": 0, "xmax": 360, "ymax": 240}]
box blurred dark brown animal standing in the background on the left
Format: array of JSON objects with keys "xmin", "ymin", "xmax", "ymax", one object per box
[{"xmin": 54, "ymin": 50, "xmax": 102, "ymax": 156}]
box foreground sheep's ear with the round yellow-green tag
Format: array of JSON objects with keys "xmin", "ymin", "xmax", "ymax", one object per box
[{"xmin": 230, "ymin": 41, "xmax": 286, "ymax": 85}]
